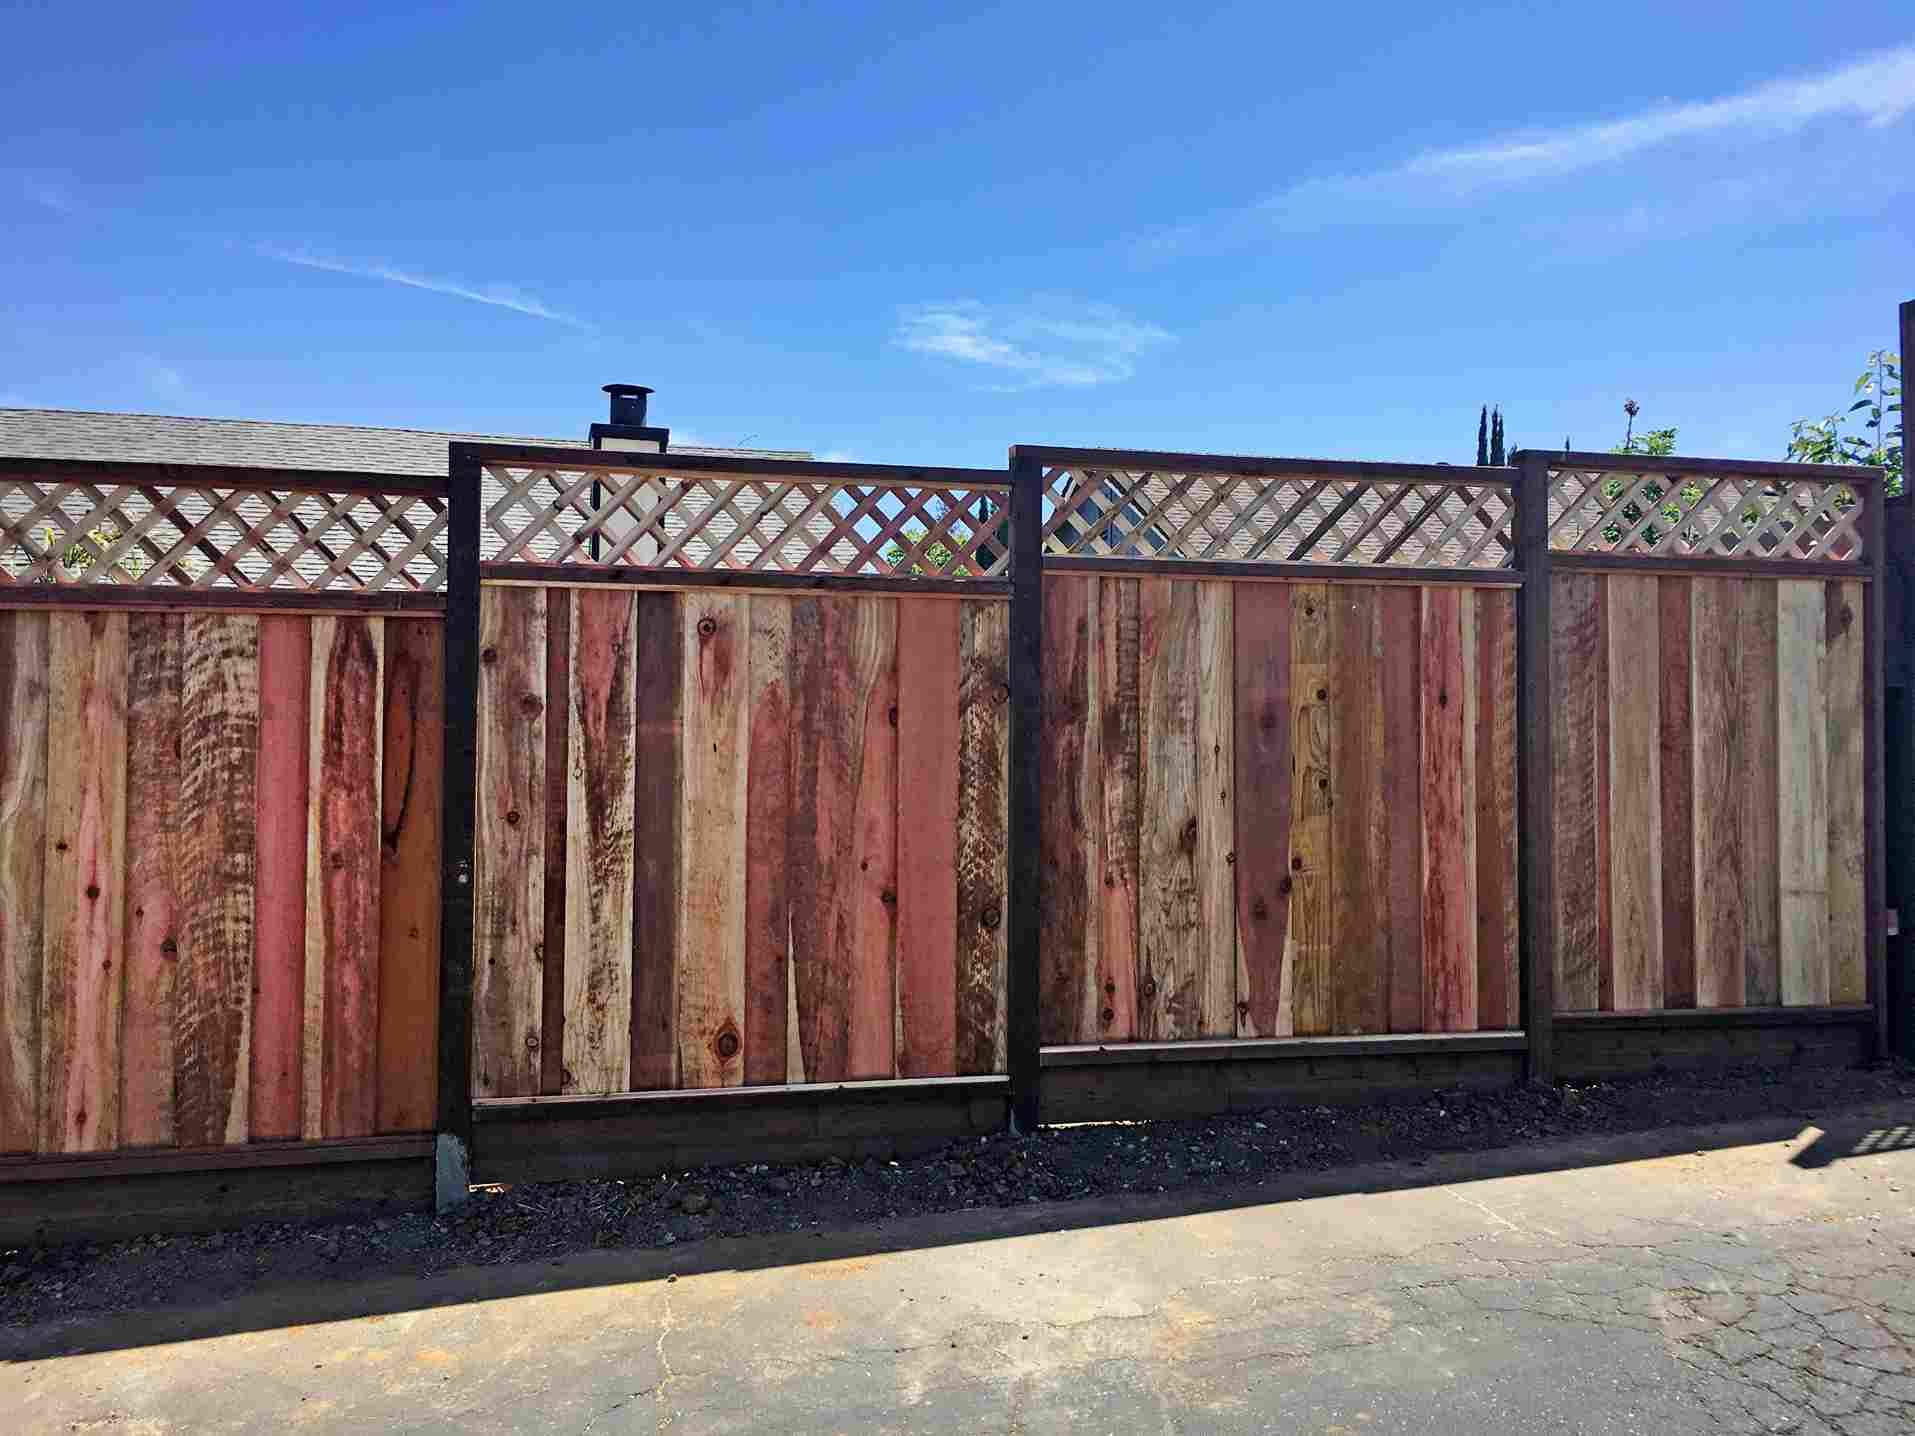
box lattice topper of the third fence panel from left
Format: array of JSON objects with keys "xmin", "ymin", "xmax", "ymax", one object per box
[{"xmin": 1044, "ymin": 465, "xmax": 1515, "ymax": 569}]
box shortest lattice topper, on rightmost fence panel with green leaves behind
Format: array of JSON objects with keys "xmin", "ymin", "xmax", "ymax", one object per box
[{"xmin": 1549, "ymin": 467, "xmax": 1865, "ymax": 561}]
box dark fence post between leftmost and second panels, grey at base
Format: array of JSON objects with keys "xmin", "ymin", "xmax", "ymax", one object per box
[{"xmin": 435, "ymin": 444, "xmax": 481, "ymax": 1210}]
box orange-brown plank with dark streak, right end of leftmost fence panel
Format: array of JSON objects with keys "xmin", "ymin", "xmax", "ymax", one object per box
[{"xmin": 377, "ymin": 618, "xmax": 446, "ymax": 1132}]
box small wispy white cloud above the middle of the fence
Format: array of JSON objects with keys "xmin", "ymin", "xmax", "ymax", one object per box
[{"xmin": 892, "ymin": 299, "xmax": 1174, "ymax": 389}]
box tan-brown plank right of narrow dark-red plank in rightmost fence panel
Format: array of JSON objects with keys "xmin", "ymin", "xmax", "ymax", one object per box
[{"xmin": 1692, "ymin": 578, "xmax": 1754, "ymax": 1007}]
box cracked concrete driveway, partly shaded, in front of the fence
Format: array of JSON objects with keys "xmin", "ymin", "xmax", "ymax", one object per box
[{"xmin": 0, "ymin": 1109, "xmax": 1915, "ymax": 1436}]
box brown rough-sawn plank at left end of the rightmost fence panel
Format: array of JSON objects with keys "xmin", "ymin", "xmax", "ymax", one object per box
[{"xmin": 1547, "ymin": 572, "xmax": 1609, "ymax": 1013}]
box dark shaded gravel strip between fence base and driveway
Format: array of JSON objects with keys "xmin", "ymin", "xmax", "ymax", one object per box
[{"xmin": 0, "ymin": 1065, "xmax": 1915, "ymax": 1325}]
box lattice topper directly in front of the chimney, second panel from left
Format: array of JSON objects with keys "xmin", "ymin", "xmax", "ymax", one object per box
[{"xmin": 481, "ymin": 461, "xmax": 1011, "ymax": 578}]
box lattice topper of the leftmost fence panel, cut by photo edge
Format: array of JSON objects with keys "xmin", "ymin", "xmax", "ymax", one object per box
[{"xmin": 0, "ymin": 480, "xmax": 446, "ymax": 594}]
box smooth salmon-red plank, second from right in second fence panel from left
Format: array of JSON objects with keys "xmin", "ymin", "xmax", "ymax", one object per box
[{"xmin": 892, "ymin": 593, "xmax": 957, "ymax": 1076}]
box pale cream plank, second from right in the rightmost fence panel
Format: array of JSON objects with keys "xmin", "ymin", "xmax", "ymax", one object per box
[{"xmin": 1775, "ymin": 578, "xmax": 1829, "ymax": 1007}]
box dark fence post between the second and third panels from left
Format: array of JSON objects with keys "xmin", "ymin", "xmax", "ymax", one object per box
[{"xmin": 1005, "ymin": 448, "xmax": 1044, "ymax": 1135}]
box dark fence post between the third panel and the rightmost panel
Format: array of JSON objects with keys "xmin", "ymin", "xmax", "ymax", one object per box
[{"xmin": 1515, "ymin": 450, "xmax": 1555, "ymax": 1082}]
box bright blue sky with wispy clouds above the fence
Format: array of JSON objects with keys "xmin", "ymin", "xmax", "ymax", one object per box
[{"xmin": 0, "ymin": 0, "xmax": 1915, "ymax": 465}]
